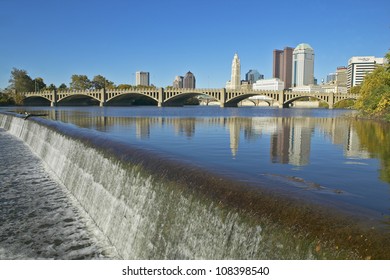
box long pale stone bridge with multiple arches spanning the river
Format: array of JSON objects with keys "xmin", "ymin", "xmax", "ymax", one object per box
[{"xmin": 22, "ymin": 88, "xmax": 357, "ymax": 109}]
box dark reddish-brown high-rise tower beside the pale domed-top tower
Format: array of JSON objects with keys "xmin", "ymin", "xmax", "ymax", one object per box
[{"xmin": 272, "ymin": 47, "xmax": 294, "ymax": 89}]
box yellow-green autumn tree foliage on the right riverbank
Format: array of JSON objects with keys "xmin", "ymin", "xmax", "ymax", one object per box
[{"xmin": 355, "ymin": 53, "xmax": 390, "ymax": 121}]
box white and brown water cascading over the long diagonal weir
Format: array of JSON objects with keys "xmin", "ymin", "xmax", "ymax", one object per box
[{"xmin": 0, "ymin": 114, "xmax": 383, "ymax": 259}]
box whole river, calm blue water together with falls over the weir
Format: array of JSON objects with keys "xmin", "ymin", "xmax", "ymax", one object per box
[{"xmin": 1, "ymin": 106, "xmax": 390, "ymax": 259}]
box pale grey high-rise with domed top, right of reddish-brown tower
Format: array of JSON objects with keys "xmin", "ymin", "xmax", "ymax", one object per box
[{"xmin": 292, "ymin": 44, "xmax": 314, "ymax": 87}]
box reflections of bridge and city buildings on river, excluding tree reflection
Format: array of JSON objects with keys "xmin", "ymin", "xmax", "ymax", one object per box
[{"xmin": 48, "ymin": 111, "xmax": 369, "ymax": 166}]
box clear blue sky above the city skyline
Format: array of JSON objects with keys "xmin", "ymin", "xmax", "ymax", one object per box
[{"xmin": 0, "ymin": 0, "xmax": 390, "ymax": 88}]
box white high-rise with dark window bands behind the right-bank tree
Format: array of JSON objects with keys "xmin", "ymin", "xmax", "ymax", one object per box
[{"xmin": 347, "ymin": 56, "xmax": 385, "ymax": 89}]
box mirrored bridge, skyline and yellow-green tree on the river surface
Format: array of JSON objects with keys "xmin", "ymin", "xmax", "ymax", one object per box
[{"xmin": 42, "ymin": 111, "xmax": 390, "ymax": 186}]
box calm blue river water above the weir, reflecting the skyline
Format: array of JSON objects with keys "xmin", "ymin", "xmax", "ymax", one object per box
[{"xmin": 2, "ymin": 106, "xmax": 390, "ymax": 258}]
